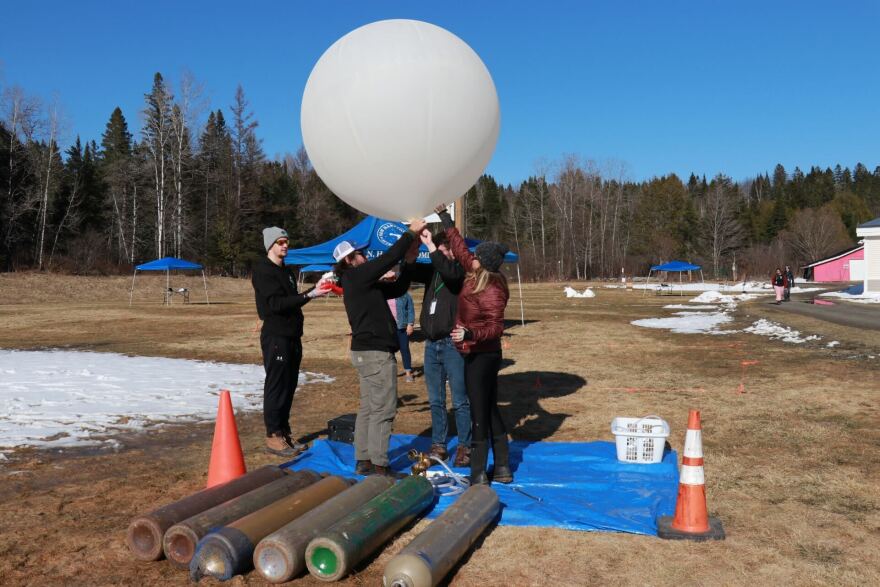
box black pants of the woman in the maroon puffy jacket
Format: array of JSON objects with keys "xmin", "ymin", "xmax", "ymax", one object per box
[{"xmin": 464, "ymin": 351, "xmax": 507, "ymax": 442}]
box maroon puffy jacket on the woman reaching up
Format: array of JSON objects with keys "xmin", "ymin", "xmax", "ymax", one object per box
[{"xmin": 446, "ymin": 228, "xmax": 510, "ymax": 353}]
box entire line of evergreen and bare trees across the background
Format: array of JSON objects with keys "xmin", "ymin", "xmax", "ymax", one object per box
[{"xmin": 0, "ymin": 73, "xmax": 880, "ymax": 280}]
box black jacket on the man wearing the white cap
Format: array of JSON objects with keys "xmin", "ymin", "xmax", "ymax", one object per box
[{"xmin": 340, "ymin": 231, "xmax": 414, "ymax": 353}]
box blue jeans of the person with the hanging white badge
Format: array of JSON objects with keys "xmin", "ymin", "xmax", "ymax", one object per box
[{"xmin": 425, "ymin": 337, "xmax": 471, "ymax": 447}]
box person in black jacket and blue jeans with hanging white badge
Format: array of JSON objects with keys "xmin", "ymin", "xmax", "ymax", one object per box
[{"xmin": 411, "ymin": 226, "xmax": 471, "ymax": 467}]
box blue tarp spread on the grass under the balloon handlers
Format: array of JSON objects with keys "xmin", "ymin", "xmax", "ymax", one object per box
[{"xmin": 285, "ymin": 434, "xmax": 678, "ymax": 535}]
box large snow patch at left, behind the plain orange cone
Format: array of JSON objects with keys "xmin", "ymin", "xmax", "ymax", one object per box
[{"xmin": 0, "ymin": 350, "xmax": 333, "ymax": 447}]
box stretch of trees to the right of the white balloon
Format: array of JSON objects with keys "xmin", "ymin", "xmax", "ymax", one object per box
[{"xmin": 465, "ymin": 156, "xmax": 880, "ymax": 280}]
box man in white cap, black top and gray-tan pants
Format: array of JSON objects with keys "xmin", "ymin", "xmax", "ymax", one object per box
[{"xmin": 333, "ymin": 219, "xmax": 425, "ymax": 475}]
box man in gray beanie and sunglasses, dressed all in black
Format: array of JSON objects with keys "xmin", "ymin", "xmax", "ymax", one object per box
[{"xmin": 251, "ymin": 226, "xmax": 330, "ymax": 458}]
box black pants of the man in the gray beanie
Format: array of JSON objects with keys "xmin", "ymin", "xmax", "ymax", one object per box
[{"xmin": 260, "ymin": 333, "xmax": 302, "ymax": 436}]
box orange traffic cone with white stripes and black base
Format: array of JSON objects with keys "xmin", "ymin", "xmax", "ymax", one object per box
[{"xmin": 657, "ymin": 410, "xmax": 724, "ymax": 540}]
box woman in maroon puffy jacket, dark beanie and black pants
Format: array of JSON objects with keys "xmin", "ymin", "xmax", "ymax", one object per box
[{"xmin": 422, "ymin": 208, "xmax": 513, "ymax": 485}]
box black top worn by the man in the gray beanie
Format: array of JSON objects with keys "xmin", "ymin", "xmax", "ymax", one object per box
[{"xmin": 251, "ymin": 257, "xmax": 311, "ymax": 337}]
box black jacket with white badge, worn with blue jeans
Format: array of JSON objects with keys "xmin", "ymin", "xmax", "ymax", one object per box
[{"xmin": 407, "ymin": 251, "xmax": 464, "ymax": 340}]
